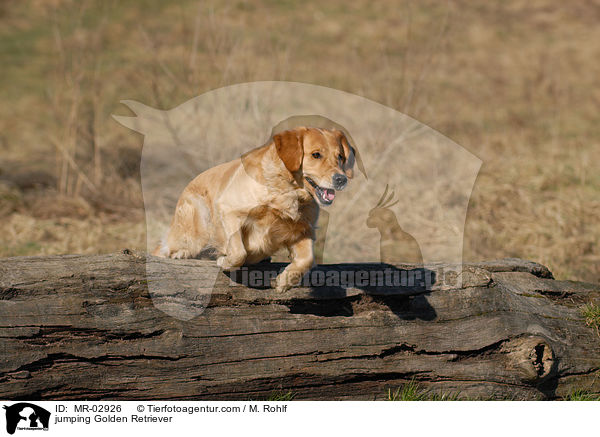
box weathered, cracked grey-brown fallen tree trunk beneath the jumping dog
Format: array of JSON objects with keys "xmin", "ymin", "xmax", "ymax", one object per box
[{"xmin": 0, "ymin": 251, "xmax": 600, "ymax": 400}]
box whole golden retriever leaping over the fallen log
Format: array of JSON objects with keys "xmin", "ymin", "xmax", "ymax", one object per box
[{"xmin": 153, "ymin": 126, "xmax": 355, "ymax": 292}]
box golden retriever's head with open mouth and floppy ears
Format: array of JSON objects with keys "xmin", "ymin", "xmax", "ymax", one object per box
[{"xmin": 273, "ymin": 127, "xmax": 355, "ymax": 205}]
